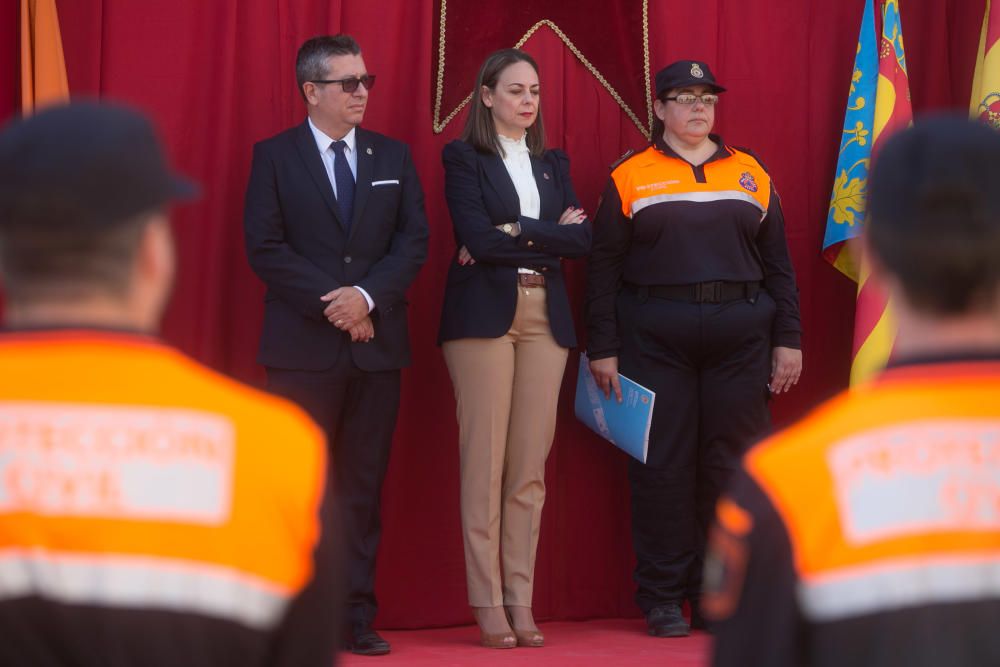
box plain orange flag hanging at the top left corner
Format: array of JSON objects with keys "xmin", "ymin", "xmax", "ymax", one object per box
[{"xmin": 21, "ymin": 0, "xmax": 69, "ymax": 115}]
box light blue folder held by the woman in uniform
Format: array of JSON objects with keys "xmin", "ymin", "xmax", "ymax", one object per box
[{"xmin": 575, "ymin": 354, "xmax": 656, "ymax": 463}]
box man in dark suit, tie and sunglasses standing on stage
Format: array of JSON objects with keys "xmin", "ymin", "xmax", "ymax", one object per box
[{"xmin": 244, "ymin": 35, "xmax": 428, "ymax": 655}]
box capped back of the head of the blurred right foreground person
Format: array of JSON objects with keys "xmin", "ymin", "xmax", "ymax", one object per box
[{"xmin": 867, "ymin": 117, "xmax": 1000, "ymax": 315}]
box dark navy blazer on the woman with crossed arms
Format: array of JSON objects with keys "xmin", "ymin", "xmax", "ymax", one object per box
[{"xmin": 438, "ymin": 141, "xmax": 591, "ymax": 347}]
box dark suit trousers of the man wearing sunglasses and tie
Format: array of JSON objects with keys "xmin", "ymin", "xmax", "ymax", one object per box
[{"xmin": 267, "ymin": 349, "xmax": 400, "ymax": 626}]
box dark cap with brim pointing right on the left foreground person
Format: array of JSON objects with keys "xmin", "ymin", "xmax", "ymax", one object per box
[{"xmin": 0, "ymin": 102, "xmax": 197, "ymax": 230}]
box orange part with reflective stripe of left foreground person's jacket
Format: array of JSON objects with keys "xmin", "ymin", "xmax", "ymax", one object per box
[{"xmin": 0, "ymin": 331, "xmax": 326, "ymax": 630}]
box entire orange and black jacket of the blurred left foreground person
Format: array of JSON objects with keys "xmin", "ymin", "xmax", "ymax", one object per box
[{"xmin": 0, "ymin": 330, "xmax": 340, "ymax": 667}]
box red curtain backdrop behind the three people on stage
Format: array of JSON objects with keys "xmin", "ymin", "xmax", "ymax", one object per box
[{"xmin": 0, "ymin": 0, "xmax": 985, "ymax": 627}]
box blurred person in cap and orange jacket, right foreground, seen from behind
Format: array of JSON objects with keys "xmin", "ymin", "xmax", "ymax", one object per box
[{"xmin": 702, "ymin": 117, "xmax": 1000, "ymax": 667}]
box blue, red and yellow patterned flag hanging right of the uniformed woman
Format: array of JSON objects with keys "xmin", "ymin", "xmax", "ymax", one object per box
[{"xmin": 823, "ymin": 0, "xmax": 913, "ymax": 385}]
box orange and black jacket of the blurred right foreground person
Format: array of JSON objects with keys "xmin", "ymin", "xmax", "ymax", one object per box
[{"xmin": 702, "ymin": 355, "xmax": 1000, "ymax": 667}]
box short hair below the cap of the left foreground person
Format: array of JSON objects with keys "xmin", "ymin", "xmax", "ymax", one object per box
[{"xmin": 0, "ymin": 211, "xmax": 156, "ymax": 303}]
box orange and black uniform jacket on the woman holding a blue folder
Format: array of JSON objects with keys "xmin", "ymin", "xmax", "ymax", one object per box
[{"xmin": 586, "ymin": 135, "xmax": 801, "ymax": 359}]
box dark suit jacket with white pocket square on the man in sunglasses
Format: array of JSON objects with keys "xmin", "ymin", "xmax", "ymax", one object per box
[{"xmin": 244, "ymin": 122, "xmax": 428, "ymax": 371}]
